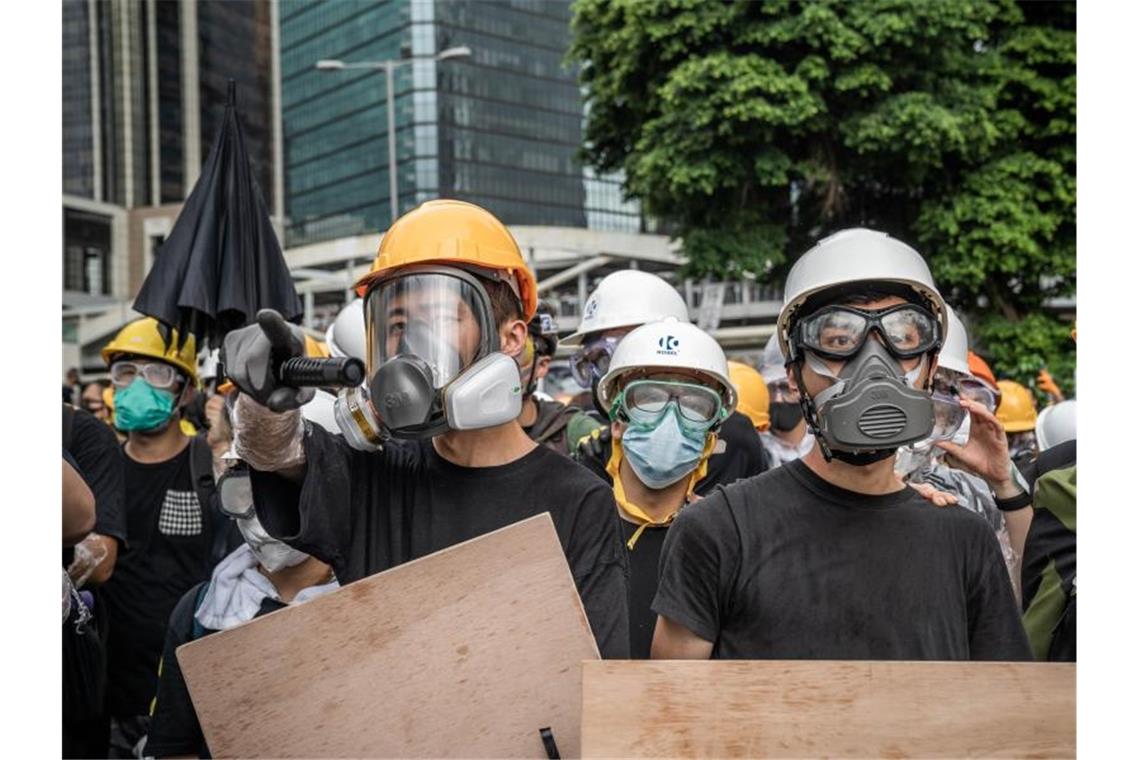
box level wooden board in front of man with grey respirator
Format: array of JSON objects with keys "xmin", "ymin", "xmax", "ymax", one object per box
[{"xmin": 581, "ymin": 660, "xmax": 1076, "ymax": 758}]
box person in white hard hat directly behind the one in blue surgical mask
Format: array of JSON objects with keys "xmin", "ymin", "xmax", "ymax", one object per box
[{"xmin": 563, "ymin": 269, "xmax": 768, "ymax": 495}]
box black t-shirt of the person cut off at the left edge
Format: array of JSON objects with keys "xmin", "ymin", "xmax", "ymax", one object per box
[{"xmin": 64, "ymin": 409, "xmax": 127, "ymax": 558}]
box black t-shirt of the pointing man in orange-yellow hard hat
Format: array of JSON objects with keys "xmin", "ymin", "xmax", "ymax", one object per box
[{"xmin": 252, "ymin": 426, "xmax": 629, "ymax": 657}]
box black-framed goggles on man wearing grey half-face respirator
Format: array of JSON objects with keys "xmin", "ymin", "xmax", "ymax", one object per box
[{"xmin": 796, "ymin": 303, "xmax": 941, "ymax": 359}]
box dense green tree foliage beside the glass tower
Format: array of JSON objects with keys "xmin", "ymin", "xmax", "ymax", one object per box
[{"xmin": 570, "ymin": 0, "xmax": 1076, "ymax": 391}]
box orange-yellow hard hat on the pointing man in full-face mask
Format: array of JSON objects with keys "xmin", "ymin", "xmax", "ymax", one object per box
[{"xmin": 356, "ymin": 199, "xmax": 538, "ymax": 321}]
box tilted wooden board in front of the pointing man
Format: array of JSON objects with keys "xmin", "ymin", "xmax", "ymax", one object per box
[{"xmin": 178, "ymin": 513, "xmax": 599, "ymax": 758}]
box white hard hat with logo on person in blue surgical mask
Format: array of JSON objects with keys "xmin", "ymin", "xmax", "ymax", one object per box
[{"xmin": 597, "ymin": 317, "xmax": 736, "ymax": 416}]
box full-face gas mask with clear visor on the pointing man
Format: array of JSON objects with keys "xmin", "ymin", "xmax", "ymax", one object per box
[{"xmin": 351, "ymin": 264, "xmax": 522, "ymax": 439}]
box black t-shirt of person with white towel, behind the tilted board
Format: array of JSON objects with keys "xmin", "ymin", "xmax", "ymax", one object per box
[{"xmin": 146, "ymin": 581, "xmax": 286, "ymax": 758}]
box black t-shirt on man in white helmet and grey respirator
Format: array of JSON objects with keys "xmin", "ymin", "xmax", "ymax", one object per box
[{"xmin": 653, "ymin": 460, "xmax": 1031, "ymax": 660}]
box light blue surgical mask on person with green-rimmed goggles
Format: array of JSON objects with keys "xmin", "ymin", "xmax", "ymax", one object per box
[{"xmin": 621, "ymin": 401, "xmax": 708, "ymax": 490}]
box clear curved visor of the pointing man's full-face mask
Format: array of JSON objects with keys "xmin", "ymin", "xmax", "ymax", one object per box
[{"xmin": 365, "ymin": 267, "xmax": 498, "ymax": 390}]
